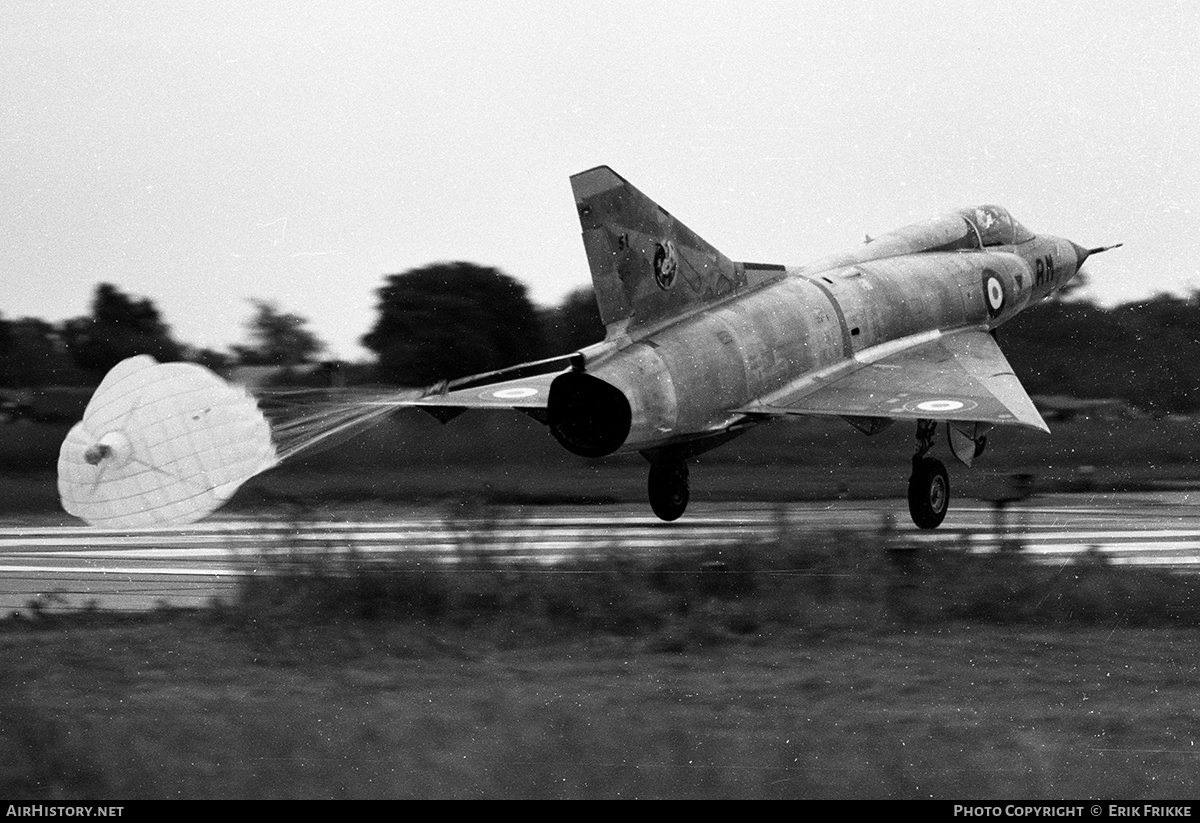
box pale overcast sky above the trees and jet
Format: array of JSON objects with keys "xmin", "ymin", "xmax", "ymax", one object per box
[{"xmin": 0, "ymin": 0, "xmax": 1200, "ymax": 359}]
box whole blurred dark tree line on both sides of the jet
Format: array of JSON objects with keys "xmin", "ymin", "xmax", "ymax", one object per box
[{"xmin": 7, "ymin": 262, "xmax": 1200, "ymax": 414}]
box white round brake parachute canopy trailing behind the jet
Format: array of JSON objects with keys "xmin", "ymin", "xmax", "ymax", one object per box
[{"xmin": 59, "ymin": 354, "xmax": 278, "ymax": 528}]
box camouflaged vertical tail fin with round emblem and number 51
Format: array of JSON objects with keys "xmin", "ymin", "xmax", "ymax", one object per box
[{"xmin": 571, "ymin": 166, "xmax": 746, "ymax": 334}]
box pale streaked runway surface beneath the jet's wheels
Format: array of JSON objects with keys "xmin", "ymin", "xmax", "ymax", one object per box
[{"xmin": 0, "ymin": 492, "xmax": 1200, "ymax": 615}]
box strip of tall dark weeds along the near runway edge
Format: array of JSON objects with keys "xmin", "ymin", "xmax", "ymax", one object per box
[{"xmin": 227, "ymin": 519, "xmax": 1200, "ymax": 650}]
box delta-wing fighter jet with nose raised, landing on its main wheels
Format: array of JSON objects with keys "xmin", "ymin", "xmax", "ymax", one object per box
[{"xmin": 398, "ymin": 166, "xmax": 1116, "ymax": 529}]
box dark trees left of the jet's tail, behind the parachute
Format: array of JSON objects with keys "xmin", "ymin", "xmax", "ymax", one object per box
[{"xmin": 0, "ymin": 262, "xmax": 604, "ymax": 389}]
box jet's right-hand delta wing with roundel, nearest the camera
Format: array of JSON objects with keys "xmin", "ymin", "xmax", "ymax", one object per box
[{"xmin": 738, "ymin": 329, "xmax": 1050, "ymax": 432}]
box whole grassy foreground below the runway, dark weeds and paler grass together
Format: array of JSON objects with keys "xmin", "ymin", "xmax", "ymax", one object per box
[{"xmin": 7, "ymin": 533, "xmax": 1200, "ymax": 800}]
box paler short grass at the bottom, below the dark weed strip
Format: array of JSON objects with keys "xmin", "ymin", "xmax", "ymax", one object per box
[{"xmin": 7, "ymin": 617, "xmax": 1200, "ymax": 800}]
